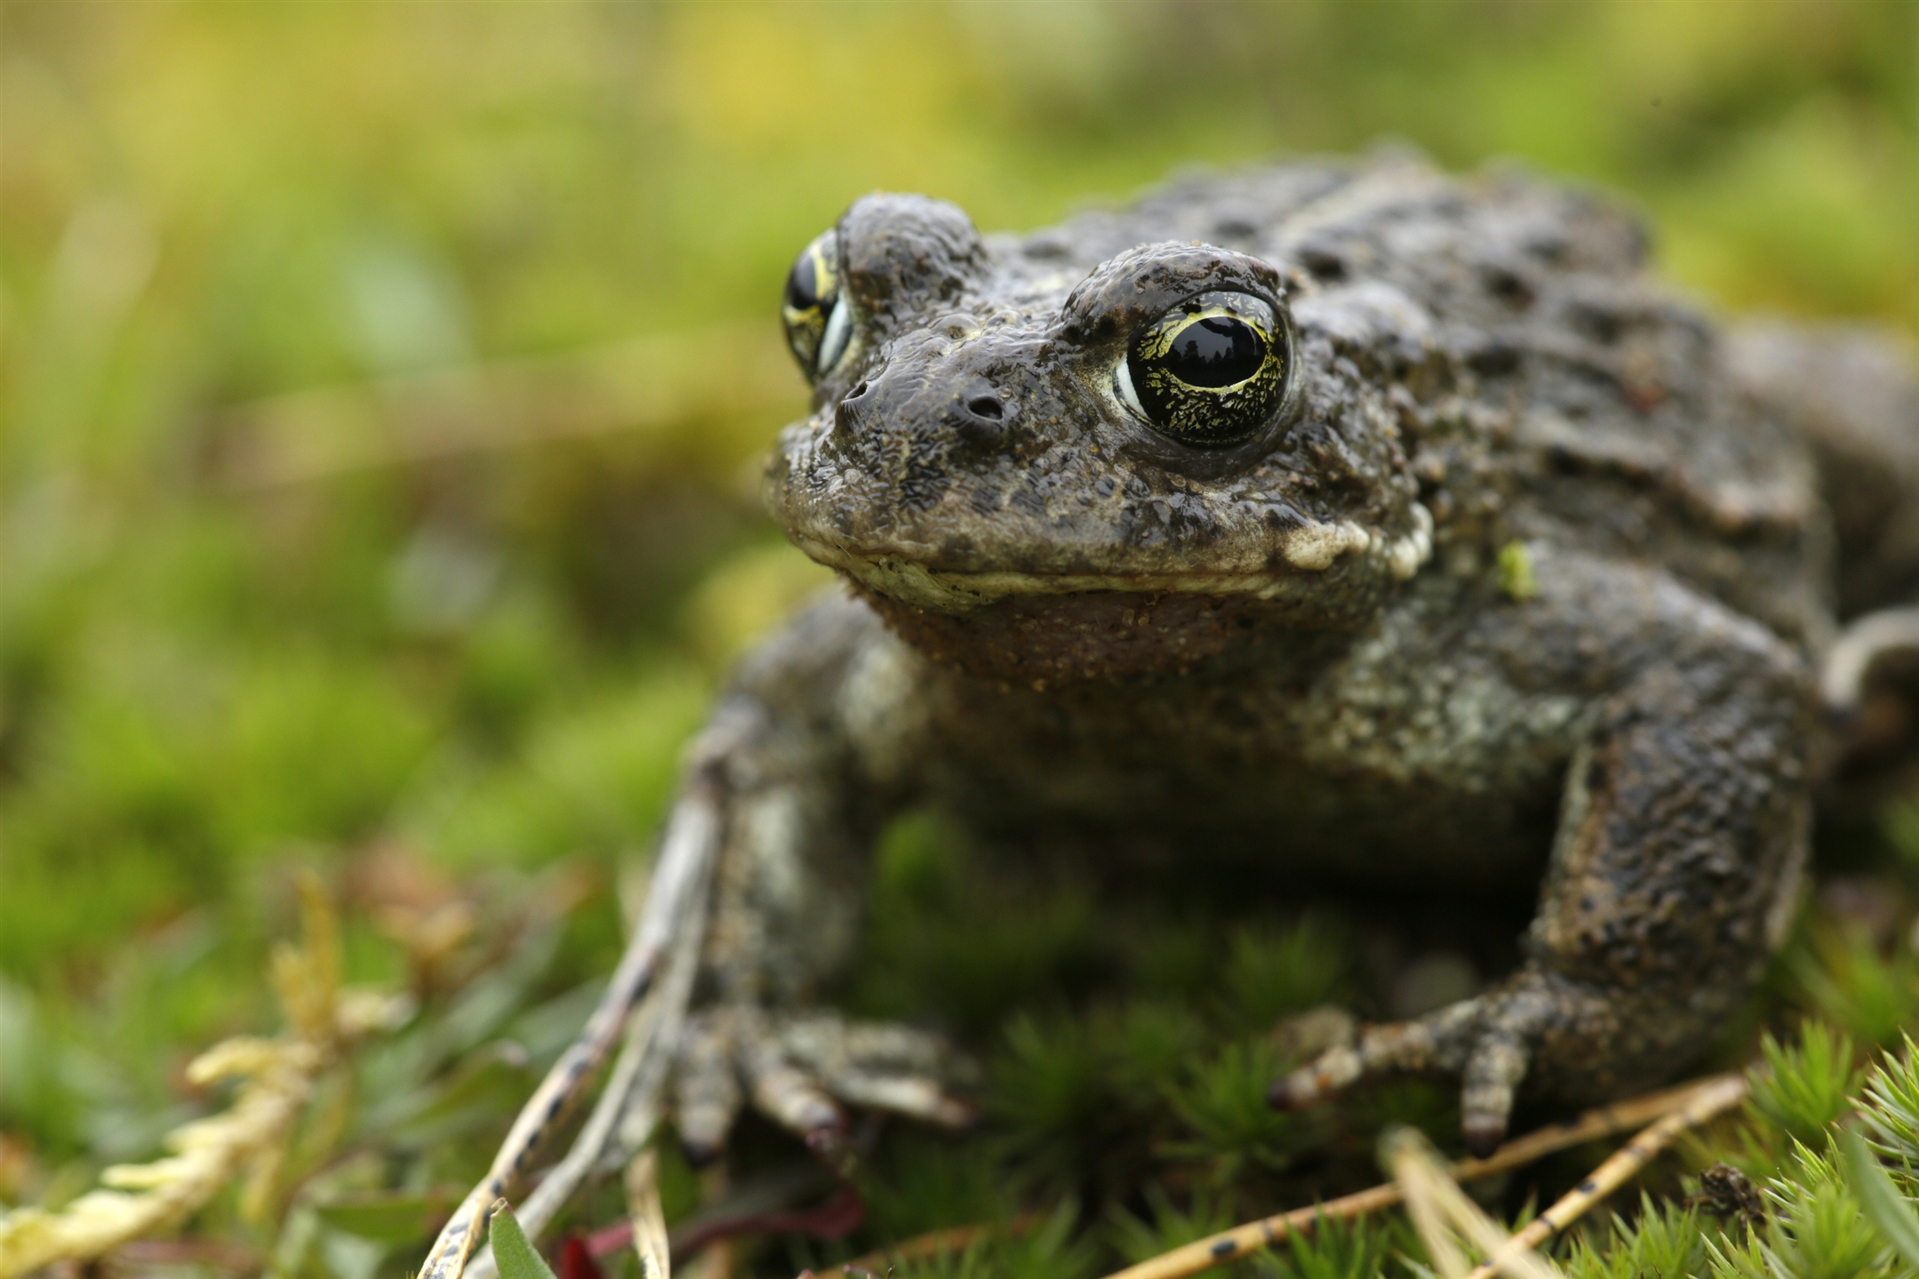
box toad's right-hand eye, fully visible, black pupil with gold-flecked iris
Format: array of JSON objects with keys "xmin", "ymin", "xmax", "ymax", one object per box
[{"xmin": 1115, "ymin": 292, "xmax": 1291, "ymax": 447}]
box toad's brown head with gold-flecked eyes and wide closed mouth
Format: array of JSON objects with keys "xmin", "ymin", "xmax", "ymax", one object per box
[{"xmin": 766, "ymin": 196, "xmax": 1432, "ymax": 680}]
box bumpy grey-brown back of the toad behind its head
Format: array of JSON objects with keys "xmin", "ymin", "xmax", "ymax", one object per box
[{"xmin": 1020, "ymin": 154, "xmax": 1833, "ymax": 645}]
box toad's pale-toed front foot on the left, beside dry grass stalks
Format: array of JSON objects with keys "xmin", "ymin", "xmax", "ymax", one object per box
[{"xmin": 675, "ymin": 1004, "xmax": 973, "ymax": 1166}]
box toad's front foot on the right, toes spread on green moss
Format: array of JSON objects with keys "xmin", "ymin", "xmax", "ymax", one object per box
[{"xmin": 1268, "ymin": 970, "xmax": 1620, "ymax": 1156}]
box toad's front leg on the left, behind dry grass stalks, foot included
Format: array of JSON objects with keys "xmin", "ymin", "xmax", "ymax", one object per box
[{"xmin": 675, "ymin": 599, "xmax": 967, "ymax": 1158}]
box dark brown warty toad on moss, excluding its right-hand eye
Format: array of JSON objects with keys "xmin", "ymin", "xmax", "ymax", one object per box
[{"xmin": 663, "ymin": 151, "xmax": 1919, "ymax": 1145}]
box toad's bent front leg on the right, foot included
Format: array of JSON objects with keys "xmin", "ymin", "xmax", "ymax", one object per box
[{"xmin": 1272, "ymin": 563, "xmax": 1812, "ymax": 1152}]
